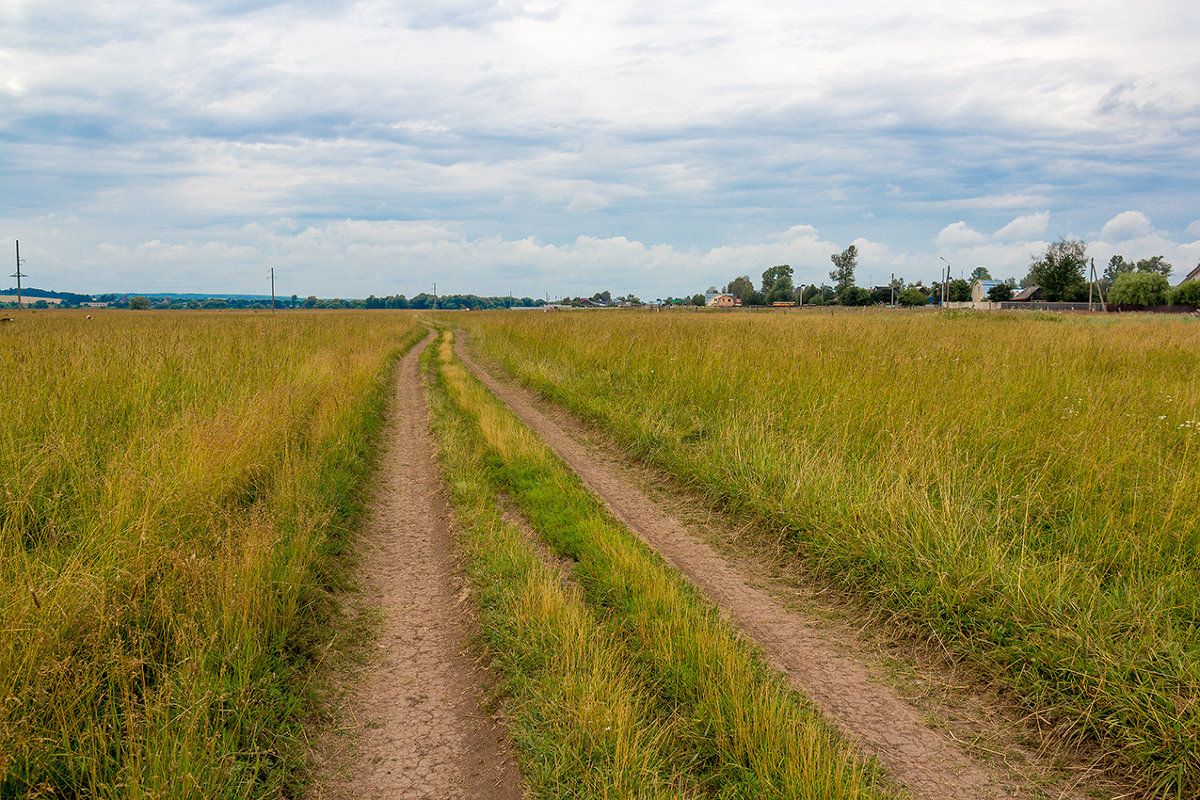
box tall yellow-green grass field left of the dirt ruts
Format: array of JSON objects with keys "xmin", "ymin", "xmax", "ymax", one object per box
[{"xmin": 0, "ymin": 313, "xmax": 418, "ymax": 798}]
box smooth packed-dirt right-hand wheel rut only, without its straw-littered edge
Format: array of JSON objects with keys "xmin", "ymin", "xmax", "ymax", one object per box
[{"xmin": 458, "ymin": 337, "xmax": 1087, "ymax": 800}]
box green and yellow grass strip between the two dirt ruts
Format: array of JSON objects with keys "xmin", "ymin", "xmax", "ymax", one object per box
[{"xmin": 427, "ymin": 331, "xmax": 900, "ymax": 799}]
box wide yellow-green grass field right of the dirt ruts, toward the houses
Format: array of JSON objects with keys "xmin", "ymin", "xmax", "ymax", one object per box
[{"xmin": 456, "ymin": 312, "xmax": 1200, "ymax": 798}]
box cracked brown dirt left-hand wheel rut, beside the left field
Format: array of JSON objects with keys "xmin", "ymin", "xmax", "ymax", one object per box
[{"xmin": 320, "ymin": 337, "xmax": 522, "ymax": 800}]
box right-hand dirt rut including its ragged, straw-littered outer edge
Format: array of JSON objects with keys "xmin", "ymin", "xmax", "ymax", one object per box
[{"xmin": 460, "ymin": 337, "xmax": 1128, "ymax": 800}]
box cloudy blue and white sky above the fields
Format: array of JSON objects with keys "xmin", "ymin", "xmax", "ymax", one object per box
[{"xmin": 0, "ymin": 0, "xmax": 1200, "ymax": 299}]
